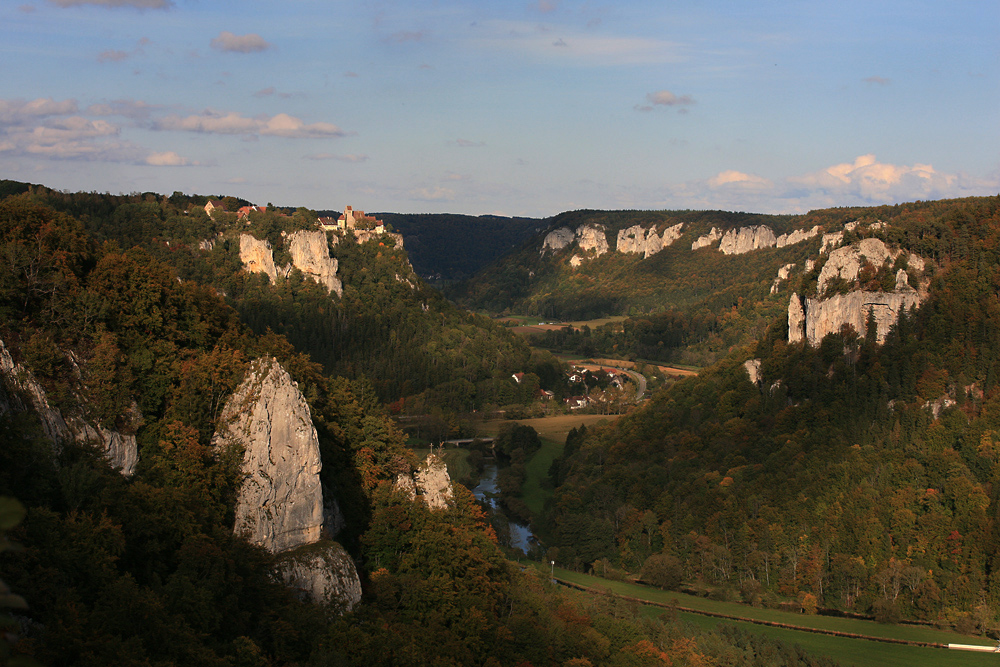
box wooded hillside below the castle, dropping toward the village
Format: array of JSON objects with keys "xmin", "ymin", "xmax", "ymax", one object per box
[{"xmin": 9, "ymin": 182, "xmax": 530, "ymax": 411}]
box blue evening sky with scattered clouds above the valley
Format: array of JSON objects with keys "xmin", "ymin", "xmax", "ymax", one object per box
[{"xmin": 0, "ymin": 0, "xmax": 1000, "ymax": 216}]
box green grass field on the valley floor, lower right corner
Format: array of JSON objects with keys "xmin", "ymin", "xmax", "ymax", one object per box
[{"xmin": 534, "ymin": 563, "xmax": 1000, "ymax": 667}]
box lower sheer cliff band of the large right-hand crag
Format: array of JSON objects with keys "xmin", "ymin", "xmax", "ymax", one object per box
[{"xmin": 788, "ymin": 282, "xmax": 922, "ymax": 346}]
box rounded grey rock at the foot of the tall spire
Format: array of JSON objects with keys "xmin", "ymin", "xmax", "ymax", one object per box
[{"xmin": 277, "ymin": 542, "xmax": 361, "ymax": 614}]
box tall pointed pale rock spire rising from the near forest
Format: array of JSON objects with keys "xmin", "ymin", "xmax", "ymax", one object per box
[{"xmin": 213, "ymin": 358, "xmax": 323, "ymax": 553}]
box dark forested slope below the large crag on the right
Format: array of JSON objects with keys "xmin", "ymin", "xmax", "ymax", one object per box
[{"xmin": 544, "ymin": 198, "xmax": 1000, "ymax": 632}]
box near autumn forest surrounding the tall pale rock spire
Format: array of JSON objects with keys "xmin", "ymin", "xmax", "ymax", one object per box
[{"xmin": 0, "ymin": 184, "xmax": 852, "ymax": 667}]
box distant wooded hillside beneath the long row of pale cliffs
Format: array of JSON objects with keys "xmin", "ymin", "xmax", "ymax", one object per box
[{"xmin": 447, "ymin": 208, "xmax": 896, "ymax": 365}]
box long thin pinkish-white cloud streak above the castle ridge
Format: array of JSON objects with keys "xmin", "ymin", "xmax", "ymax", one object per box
[{"xmin": 154, "ymin": 109, "xmax": 346, "ymax": 139}]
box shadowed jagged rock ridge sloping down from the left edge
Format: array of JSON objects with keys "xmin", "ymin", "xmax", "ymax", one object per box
[{"xmin": 0, "ymin": 340, "xmax": 141, "ymax": 477}]
